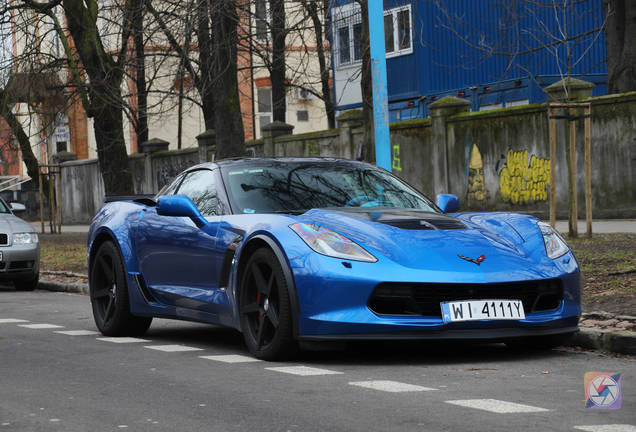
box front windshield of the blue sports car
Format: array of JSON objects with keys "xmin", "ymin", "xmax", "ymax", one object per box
[{"xmin": 221, "ymin": 161, "xmax": 438, "ymax": 213}]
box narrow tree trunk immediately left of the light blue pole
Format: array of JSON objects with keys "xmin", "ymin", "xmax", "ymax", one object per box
[{"xmin": 358, "ymin": 0, "xmax": 375, "ymax": 164}]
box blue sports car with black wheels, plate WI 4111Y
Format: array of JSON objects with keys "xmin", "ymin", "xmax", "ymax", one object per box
[{"xmin": 88, "ymin": 158, "xmax": 581, "ymax": 360}]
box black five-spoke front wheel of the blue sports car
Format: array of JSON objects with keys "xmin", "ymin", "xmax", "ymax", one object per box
[{"xmin": 239, "ymin": 248, "xmax": 296, "ymax": 360}]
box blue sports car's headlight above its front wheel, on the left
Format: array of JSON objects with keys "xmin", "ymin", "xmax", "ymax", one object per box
[{"xmin": 289, "ymin": 223, "xmax": 378, "ymax": 262}]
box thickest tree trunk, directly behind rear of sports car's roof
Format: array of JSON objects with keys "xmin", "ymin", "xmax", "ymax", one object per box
[{"xmin": 212, "ymin": 0, "xmax": 245, "ymax": 159}]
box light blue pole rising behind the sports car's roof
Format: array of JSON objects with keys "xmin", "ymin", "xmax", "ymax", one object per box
[{"xmin": 369, "ymin": 0, "xmax": 391, "ymax": 171}]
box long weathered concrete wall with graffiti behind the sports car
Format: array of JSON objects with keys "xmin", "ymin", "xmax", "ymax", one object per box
[{"xmin": 62, "ymin": 92, "xmax": 636, "ymax": 223}]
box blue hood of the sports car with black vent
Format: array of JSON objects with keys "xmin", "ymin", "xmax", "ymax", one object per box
[{"xmin": 300, "ymin": 208, "xmax": 552, "ymax": 277}]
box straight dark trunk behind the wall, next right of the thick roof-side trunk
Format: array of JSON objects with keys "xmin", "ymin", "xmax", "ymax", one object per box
[{"xmin": 269, "ymin": 0, "xmax": 287, "ymax": 122}]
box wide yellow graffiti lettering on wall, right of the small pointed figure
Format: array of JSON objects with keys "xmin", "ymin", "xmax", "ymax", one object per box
[{"xmin": 499, "ymin": 150, "xmax": 550, "ymax": 204}]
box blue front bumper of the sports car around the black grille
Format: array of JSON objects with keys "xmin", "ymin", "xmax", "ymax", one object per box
[{"xmin": 292, "ymin": 253, "xmax": 581, "ymax": 340}]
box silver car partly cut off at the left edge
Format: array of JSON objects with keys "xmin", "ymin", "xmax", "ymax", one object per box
[{"xmin": 0, "ymin": 198, "xmax": 40, "ymax": 291}]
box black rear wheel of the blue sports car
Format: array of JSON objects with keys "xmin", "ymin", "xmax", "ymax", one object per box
[{"xmin": 89, "ymin": 241, "xmax": 152, "ymax": 336}]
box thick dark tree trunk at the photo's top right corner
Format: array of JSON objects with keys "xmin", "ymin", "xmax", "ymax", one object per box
[{"xmin": 603, "ymin": 0, "xmax": 636, "ymax": 94}]
